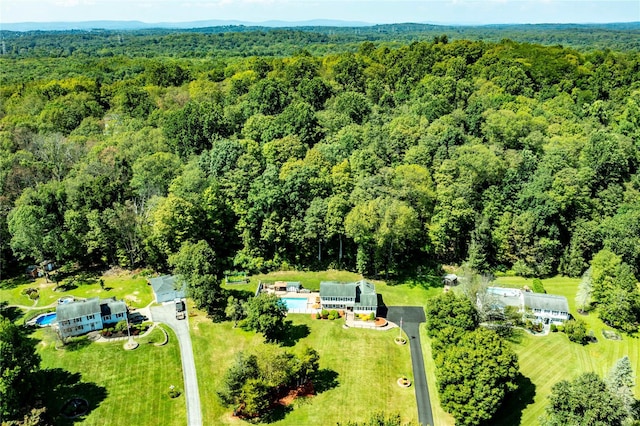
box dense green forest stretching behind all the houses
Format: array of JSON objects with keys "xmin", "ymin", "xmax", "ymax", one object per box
[{"xmin": 0, "ymin": 30, "xmax": 640, "ymax": 292}]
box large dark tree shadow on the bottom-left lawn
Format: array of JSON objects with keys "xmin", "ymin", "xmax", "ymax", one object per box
[{"xmin": 37, "ymin": 368, "xmax": 107, "ymax": 426}]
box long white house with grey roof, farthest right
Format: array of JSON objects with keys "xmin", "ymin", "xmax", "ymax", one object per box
[{"xmin": 477, "ymin": 287, "xmax": 570, "ymax": 325}]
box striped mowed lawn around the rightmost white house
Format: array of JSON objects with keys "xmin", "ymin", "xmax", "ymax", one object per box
[{"xmin": 497, "ymin": 277, "xmax": 640, "ymax": 425}]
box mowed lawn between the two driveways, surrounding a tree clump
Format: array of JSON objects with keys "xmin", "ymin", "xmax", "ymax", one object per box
[{"xmin": 190, "ymin": 314, "xmax": 418, "ymax": 425}]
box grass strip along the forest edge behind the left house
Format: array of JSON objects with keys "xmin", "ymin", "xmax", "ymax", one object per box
[{"xmin": 0, "ymin": 271, "xmax": 153, "ymax": 308}]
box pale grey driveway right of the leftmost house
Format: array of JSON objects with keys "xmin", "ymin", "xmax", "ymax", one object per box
[{"xmin": 151, "ymin": 303, "xmax": 202, "ymax": 426}]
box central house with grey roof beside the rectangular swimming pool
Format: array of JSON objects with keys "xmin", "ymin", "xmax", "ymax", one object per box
[{"xmin": 320, "ymin": 280, "xmax": 378, "ymax": 314}]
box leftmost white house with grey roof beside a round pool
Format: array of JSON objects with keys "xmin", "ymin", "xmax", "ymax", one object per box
[{"xmin": 56, "ymin": 297, "xmax": 127, "ymax": 338}]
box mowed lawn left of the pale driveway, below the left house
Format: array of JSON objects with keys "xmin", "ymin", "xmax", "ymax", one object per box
[{"xmin": 34, "ymin": 329, "xmax": 187, "ymax": 426}]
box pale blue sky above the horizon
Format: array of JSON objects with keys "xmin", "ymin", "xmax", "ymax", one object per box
[{"xmin": 0, "ymin": 0, "xmax": 640, "ymax": 25}]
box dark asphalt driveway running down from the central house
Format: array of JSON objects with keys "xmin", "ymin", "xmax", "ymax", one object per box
[{"xmin": 387, "ymin": 306, "xmax": 433, "ymax": 426}]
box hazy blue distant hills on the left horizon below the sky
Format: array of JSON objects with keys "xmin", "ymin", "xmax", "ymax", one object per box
[{"xmin": 0, "ymin": 19, "xmax": 372, "ymax": 31}]
